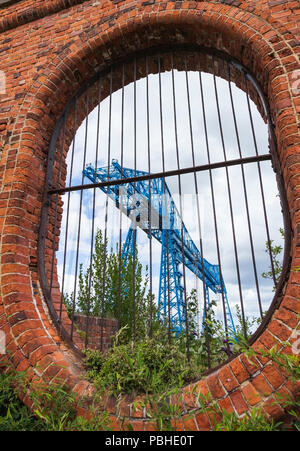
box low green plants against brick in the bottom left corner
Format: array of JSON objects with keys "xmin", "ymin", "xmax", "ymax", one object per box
[{"xmin": 0, "ymin": 370, "xmax": 108, "ymax": 431}]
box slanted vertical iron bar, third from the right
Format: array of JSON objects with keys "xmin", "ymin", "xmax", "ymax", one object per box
[{"xmin": 213, "ymin": 60, "xmax": 247, "ymax": 339}]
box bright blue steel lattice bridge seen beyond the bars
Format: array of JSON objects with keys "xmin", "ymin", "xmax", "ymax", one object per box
[{"xmin": 83, "ymin": 160, "xmax": 236, "ymax": 336}]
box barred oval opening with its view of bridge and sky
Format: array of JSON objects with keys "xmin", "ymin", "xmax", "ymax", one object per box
[{"xmin": 41, "ymin": 51, "xmax": 284, "ymax": 369}]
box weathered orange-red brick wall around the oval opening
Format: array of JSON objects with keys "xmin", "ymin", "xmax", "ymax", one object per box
[{"xmin": 0, "ymin": 0, "xmax": 300, "ymax": 430}]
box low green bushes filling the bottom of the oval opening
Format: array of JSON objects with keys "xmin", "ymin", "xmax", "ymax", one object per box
[{"xmin": 85, "ymin": 292, "xmax": 238, "ymax": 397}]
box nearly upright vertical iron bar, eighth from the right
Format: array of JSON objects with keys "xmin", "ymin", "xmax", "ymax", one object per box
[{"xmin": 146, "ymin": 56, "xmax": 153, "ymax": 338}]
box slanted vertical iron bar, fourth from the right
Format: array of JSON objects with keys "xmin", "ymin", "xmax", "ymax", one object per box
[{"xmin": 199, "ymin": 57, "xmax": 228, "ymax": 338}]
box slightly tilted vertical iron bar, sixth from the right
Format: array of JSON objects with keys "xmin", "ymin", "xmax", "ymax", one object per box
[{"xmin": 171, "ymin": 52, "xmax": 190, "ymax": 362}]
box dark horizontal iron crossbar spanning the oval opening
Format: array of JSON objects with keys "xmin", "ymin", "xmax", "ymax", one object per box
[{"xmin": 48, "ymin": 153, "xmax": 272, "ymax": 194}]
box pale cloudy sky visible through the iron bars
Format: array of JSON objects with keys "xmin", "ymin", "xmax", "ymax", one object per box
[{"xmin": 58, "ymin": 67, "xmax": 283, "ymax": 334}]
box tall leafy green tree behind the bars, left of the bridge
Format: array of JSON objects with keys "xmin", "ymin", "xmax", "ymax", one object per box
[{"xmin": 65, "ymin": 229, "xmax": 161, "ymax": 339}]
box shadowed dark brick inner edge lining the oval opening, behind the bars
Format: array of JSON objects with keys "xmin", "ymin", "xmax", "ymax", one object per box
[{"xmin": 38, "ymin": 45, "xmax": 276, "ymax": 352}]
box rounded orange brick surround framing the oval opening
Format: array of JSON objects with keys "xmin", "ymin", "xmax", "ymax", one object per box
[{"xmin": 0, "ymin": 2, "xmax": 300, "ymax": 430}]
